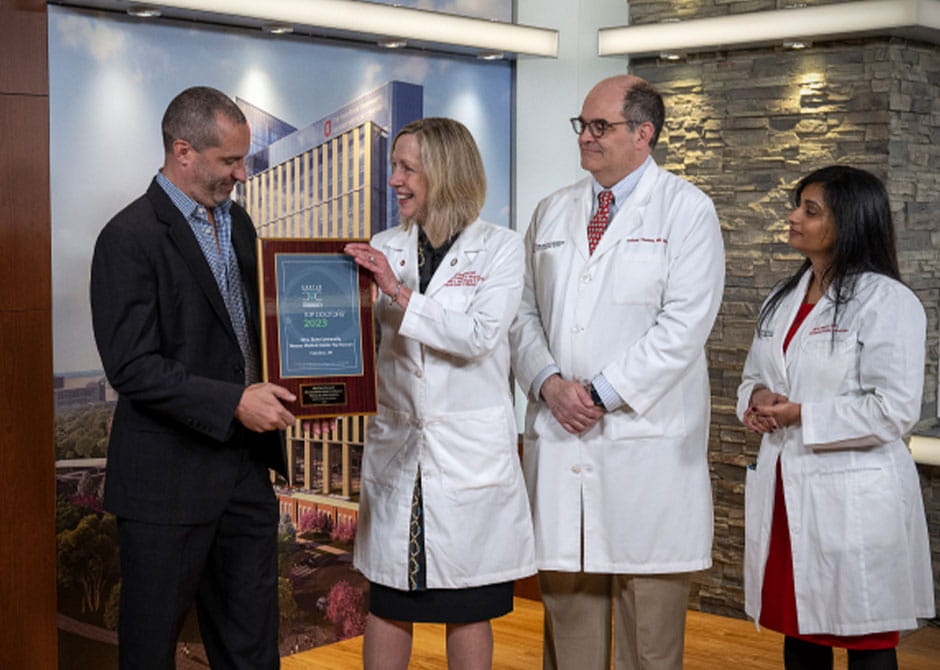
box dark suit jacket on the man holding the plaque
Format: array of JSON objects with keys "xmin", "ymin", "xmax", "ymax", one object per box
[{"xmin": 91, "ymin": 181, "xmax": 285, "ymax": 524}]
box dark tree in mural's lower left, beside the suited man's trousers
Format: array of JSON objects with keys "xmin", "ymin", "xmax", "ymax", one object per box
[{"xmin": 56, "ymin": 514, "xmax": 119, "ymax": 612}]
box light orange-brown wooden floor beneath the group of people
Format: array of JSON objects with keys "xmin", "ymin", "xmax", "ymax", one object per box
[{"xmin": 281, "ymin": 598, "xmax": 940, "ymax": 670}]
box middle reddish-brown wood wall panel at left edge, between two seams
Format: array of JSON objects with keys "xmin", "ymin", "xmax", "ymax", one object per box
[{"xmin": 0, "ymin": 94, "xmax": 51, "ymax": 310}]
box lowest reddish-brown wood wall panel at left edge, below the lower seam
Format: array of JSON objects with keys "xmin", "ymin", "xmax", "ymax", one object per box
[{"xmin": 0, "ymin": 310, "xmax": 57, "ymax": 670}]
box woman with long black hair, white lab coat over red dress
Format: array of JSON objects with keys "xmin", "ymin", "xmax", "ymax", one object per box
[{"xmin": 737, "ymin": 166, "xmax": 934, "ymax": 670}]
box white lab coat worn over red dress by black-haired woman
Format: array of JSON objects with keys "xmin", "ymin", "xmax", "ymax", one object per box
[{"xmin": 737, "ymin": 272, "xmax": 934, "ymax": 635}]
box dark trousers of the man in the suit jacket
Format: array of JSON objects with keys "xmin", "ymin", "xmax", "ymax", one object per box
[{"xmin": 118, "ymin": 458, "xmax": 280, "ymax": 670}]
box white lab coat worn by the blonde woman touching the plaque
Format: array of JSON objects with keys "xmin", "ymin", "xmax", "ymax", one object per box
[{"xmin": 354, "ymin": 221, "xmax": 535, "ymax": 589}]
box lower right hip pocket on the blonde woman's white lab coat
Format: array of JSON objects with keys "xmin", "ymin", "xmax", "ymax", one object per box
[{"xmin": 429, "ymin": 407, "xmax": 518, "ymax": 504}]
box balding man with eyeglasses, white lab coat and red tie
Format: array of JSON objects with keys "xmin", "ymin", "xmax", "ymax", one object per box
[{"xmin": 511, "ymin": 75, "xmax": 724, "ymax": 670}]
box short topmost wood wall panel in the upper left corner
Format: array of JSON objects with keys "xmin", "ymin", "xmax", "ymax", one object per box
[{"xmin": 0, "ymin": 0, "xmax": 49, "ymax": 95}]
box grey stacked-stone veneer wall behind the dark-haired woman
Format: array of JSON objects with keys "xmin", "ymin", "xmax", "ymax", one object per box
[{"xmin": 629, "ymin": 0, "xmax": 940, "ymax": 616}]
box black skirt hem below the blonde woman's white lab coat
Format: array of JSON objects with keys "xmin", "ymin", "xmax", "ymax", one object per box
[{"xmin": 369, "ymin": 582, "xmax": 513, "ymax": 623}]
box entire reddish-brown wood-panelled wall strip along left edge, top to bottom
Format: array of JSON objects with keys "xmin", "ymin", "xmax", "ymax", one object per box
[{"xmin": 0, "ymin": 0, "xmax": 58, "ymax": 670}]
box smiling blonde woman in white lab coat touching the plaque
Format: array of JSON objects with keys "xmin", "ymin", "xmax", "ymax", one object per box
[{"xmin": 346, "ymin": 118, "xmax": 535, "ymax": 670}]
